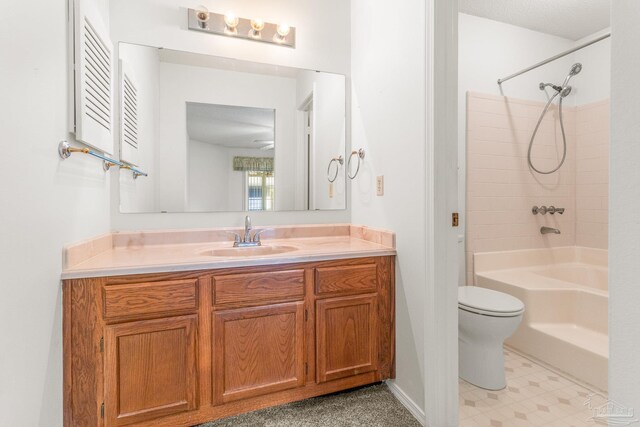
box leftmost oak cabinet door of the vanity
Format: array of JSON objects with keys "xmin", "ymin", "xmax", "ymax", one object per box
[{"xmin": 104, "ymin": 315, "xmax": 198, "ymax": 426}]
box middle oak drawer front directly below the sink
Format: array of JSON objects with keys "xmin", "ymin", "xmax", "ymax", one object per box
[{"xmin": 213, "ymin": 270, "xmax": 304, "ymax": 307}]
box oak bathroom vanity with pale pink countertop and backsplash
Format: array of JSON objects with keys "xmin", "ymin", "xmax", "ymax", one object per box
[{"xmin": 63, "ymin": 225, "xmax": 395, "ymax": 426}]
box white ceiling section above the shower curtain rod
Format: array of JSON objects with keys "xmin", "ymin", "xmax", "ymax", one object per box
[{"xmin": 459, "ymin": 0, "xmax": 611, "ymax": 40}]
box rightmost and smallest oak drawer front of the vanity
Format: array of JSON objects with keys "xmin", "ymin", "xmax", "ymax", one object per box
[{"xmin": 316, "ymin": 264, "xmax": 378, "ymax": 295}]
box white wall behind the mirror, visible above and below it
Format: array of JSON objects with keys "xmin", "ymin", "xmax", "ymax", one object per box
[{"xmin": 109, "ymin": 0, "xmax": 351, "ymax": 230}]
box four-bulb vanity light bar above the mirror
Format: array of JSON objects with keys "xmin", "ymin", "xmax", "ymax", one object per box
[{"xmin": 188, "ymin": 6, "xmax": 296, "ymax": 49}]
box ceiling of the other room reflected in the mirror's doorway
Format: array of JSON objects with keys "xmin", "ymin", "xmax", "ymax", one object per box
[{"xmin": 187, "ymin": 102, "xmax": 275, "ymax": 149}]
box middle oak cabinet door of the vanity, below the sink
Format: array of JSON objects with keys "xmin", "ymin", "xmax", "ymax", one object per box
[{"xmin": 213, "ymin": 301, "xmax": 305, "ymax": 404}]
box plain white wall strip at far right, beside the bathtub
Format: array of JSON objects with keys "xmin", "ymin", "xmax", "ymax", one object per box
[{"xmin": 609, "ymin": 0, "xmax": 640, "ymax": 417}]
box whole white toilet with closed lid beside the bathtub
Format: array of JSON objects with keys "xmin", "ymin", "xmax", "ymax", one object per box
[{"xmin": 458, "ymin": 286, "xmax": 524, "ymax": 390}]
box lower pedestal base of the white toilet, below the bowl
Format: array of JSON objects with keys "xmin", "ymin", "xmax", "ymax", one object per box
[{"xmin": 458, "ymin": 338, "xmax": 507, "ymax": 390}]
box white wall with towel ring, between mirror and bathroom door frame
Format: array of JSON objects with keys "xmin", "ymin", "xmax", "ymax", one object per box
[{"xmin": 351, "ymin": 0, "xmax": 427, "ymax": 418}]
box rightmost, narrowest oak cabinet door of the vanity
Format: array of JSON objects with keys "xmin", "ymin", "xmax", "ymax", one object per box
[{"xmin": 316, "ymin": 294, "xmax": 378, "ymax": 383}]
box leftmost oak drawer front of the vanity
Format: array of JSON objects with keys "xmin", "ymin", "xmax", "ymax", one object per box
[{"xmin": 103, "ymin": 279, "xmax": 198, "ymax": 320}]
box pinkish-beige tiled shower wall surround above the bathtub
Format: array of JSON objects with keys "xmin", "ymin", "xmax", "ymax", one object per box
[{"xmin": 466, "ymin": 92, "xmax": 609, "ymax": 283}]
